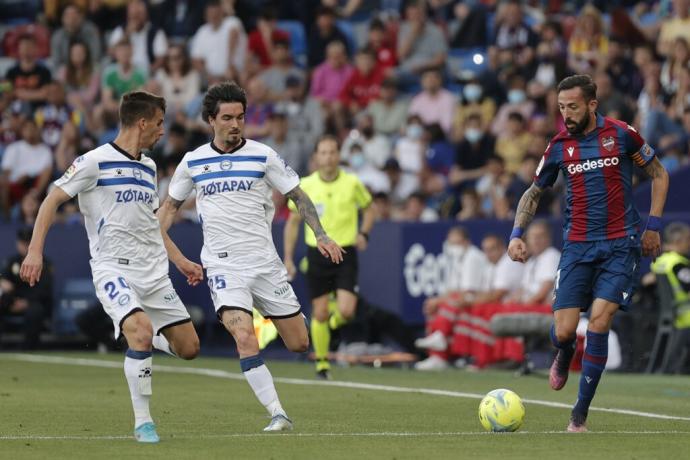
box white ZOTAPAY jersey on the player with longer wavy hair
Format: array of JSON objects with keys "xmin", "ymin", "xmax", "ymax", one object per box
[{"xmin": 168, "ymin": 139, "xmax": 299, "ymax": 270}]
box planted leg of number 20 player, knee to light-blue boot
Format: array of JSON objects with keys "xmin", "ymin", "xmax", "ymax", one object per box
[{"xmin": 122, "ymin": 311, "xmax": 159, "ymax": 443}]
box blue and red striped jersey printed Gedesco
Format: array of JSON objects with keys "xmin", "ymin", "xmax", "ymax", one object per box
[{"xmin": 534, "ymin": 114, "xmax": 655, "ymax": 241}]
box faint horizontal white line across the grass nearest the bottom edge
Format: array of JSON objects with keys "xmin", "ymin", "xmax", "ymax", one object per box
[{"xmin": 0, "ymin": 431, "xmax": 690, "ymax": 441}]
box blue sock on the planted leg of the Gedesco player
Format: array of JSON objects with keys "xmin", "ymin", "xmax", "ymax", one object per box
[{"xmin": 573, "ymin": 331, "xmax": 609, "ymax": 417}]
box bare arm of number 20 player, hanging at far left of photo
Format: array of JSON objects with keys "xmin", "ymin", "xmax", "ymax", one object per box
[{"xmin": 19, "ymin": 187, "xmax": 71, "ymax": 287}]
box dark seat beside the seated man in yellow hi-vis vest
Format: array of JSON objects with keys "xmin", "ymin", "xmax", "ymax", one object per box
[{"xmin": 645, "ymin": 275, "xmax": 680, "ymax": 374}]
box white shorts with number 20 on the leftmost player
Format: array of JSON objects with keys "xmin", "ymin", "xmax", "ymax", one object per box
[{"xmin": 92, "ymin": 266, "xmax": 191, "ymax": 339}]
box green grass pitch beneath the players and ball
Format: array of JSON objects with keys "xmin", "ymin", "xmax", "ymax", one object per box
[{"xmin": 0, "ymin": 354, "xmax": 690, "ymax": 459}]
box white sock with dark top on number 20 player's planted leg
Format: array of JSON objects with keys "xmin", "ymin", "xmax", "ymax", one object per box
[{"xmin": 125, "ymin": 349, "xmax": 153, "ymax": 428}]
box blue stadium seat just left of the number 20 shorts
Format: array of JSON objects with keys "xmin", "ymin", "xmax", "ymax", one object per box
[{"xmin": 53, "ymin": 278, "xmax": 98, "ymax": 335}]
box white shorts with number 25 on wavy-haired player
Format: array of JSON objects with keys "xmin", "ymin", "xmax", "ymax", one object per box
[{"xmin": 206, "ymin": 261, "xmax": 300, "ymax": 319}]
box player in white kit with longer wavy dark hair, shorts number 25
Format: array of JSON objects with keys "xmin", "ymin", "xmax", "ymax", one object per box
[{"xmin": 158, "ymin": 83, "xmax": 343, "ymax": 431}]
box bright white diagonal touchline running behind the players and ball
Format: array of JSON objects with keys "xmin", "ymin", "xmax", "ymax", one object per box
[{"xmin": 5, "ymin": 353, "xmax": 690, "ymax": 421}]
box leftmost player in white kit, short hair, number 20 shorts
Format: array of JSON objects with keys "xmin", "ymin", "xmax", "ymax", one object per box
[{"xmin": 20, "ymin": 91, "xmax": 203, "ymax": 443}]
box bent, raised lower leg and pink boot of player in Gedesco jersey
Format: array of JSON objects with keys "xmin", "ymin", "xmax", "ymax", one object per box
[{"xmin": 549, "ymin": 307, "xmax": 580, "ymax": 391}]
